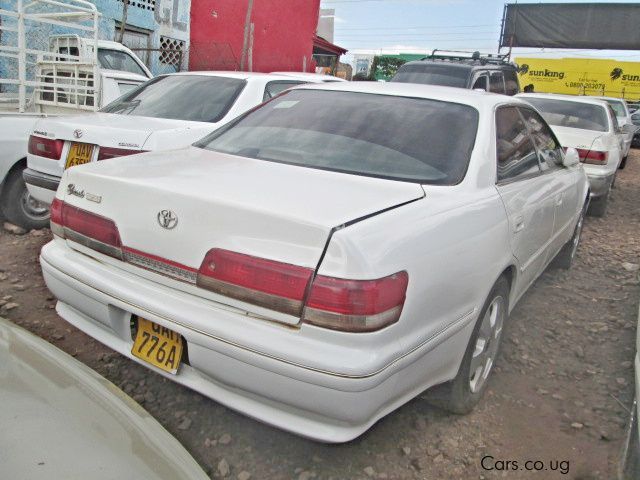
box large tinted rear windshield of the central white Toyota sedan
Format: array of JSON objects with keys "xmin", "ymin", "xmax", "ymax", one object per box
[{"xmin": 196, "ymin": 89, "xmax": 478, "ymax": 185}]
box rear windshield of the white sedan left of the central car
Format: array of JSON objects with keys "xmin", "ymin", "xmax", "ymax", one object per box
[{"xmin": 101, "ymin": 75, "xmax": 246, "ymax": 122}]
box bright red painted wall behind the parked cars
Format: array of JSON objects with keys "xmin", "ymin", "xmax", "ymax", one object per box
[{"xmin": 189, "ymin": 0, "xmax": 320, "ymax": 72}]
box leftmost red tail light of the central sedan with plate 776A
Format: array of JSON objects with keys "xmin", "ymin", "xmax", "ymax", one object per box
[{"xmin": 50, "ymin": 198, "xmax": 122, "ymax": 259}]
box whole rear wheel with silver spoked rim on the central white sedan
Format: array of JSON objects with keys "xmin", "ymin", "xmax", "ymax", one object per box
[{"xmin": 427, "ymin": 277, "xmax": 509, "ymax": 414}]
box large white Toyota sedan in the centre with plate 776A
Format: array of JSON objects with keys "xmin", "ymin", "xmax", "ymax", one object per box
[{"xmin": 40, "ymin": 82, "xmax": 588, "ymax": 442}]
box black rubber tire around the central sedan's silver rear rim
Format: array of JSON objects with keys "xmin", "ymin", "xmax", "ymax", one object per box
[{"xmin": 426, "ymin": 276, "xmax": 509, "ymax": 415}]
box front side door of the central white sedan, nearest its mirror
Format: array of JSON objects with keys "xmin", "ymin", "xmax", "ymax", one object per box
[{"xmin": 519, "ymin": 107, "xmax": 582, "ymax": 254}]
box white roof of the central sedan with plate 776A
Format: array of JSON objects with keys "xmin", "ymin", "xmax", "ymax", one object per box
[{"xmin": 293, "ymin": 82, "xmax": 529, "ymax": 109}]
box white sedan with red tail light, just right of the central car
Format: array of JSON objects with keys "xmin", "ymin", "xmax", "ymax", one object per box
[{"xmin": 517, "ymin": 93, "xmax": 635, "ymax": 217}]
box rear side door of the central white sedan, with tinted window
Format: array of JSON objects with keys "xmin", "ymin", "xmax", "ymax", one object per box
[{"xmin": 495, "ymin": 106, "xmax": 555, "ymax": 287}]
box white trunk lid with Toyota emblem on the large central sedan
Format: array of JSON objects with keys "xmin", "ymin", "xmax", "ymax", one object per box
[{"xmin": 58, "ymin": 147, "xmax": 424, "ymax": 269}]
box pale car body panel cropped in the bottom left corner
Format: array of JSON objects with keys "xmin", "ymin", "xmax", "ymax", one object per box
[{"xmin": 0, "ymin": 318, "xmax": 208, "ymax": 480}]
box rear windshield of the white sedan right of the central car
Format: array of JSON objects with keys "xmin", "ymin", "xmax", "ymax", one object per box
[{"xmin": 524, "ymin": 97, "xmax": 609, "ymax": 132}]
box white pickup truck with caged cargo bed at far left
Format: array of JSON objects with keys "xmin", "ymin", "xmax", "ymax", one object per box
[{"xmin": 0, "ymin": 0, "xmax": 152, "ymax": 229}]
